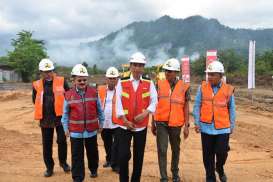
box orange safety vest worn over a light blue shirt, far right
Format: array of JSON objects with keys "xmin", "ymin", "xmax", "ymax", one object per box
[{"xmin": 200, "ymin": 81, "xmax": 234, "ymax": 129}]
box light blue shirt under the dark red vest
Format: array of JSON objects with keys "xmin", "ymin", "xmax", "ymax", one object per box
[{"xmin": 61, "ymin": 88, "xmax": 104, "ymax": 138}]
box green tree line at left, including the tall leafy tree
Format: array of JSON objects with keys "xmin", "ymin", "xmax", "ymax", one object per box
[{"xmin": 0, "ymin": 30, "xmax": 104, "ymax": 82}]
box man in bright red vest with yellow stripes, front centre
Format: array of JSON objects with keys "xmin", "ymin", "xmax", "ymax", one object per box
[{"xmin": 115, "ymin": 52, "xmax": 157, "ymax": 182}]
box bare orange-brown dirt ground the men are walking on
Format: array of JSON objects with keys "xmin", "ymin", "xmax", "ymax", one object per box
[{"xmin": 0, "ymin": 90, "xmax": 273, "ymax": 182}]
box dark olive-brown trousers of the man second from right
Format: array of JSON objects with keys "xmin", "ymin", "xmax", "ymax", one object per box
[{"xmin": 156, "ymin": 122, "xmax": 181, "ymax": 181}]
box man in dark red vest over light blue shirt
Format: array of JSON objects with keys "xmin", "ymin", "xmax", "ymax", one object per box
[{"xmin": 62, "ymin": 64, "xmax": 104, "ymax": 182}]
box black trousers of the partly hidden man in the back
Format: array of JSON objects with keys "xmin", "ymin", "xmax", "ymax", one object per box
[{"xmin": 101, "ymin": 128, "xmax": 121, "ymax": 168}]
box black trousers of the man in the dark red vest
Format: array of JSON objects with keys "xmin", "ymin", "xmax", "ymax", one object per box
[{"xmin": 70, "ymin": 135, "xmax": 99, "ymax": 181}]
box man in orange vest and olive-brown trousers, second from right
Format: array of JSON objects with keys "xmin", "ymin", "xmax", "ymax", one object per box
[{"xmin": 152, "ymin": 58, "xmax": 190, "ymax": 182}]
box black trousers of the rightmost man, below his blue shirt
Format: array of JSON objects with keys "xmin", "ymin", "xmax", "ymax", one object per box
[{"xmin": 201, "ymin": 133, "xmax": 229, "ymax": 182}]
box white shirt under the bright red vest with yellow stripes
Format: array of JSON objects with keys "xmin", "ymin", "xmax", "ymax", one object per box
[{"xmin": 116, "ymin": 75, "xmax": 157, "ymax": 131}]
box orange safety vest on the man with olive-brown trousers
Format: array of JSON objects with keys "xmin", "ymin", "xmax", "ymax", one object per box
[{"xmin": 154, "ymin": 80, "xmax": 190, "ymax": 126}]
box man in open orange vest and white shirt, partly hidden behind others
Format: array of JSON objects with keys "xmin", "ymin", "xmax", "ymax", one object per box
[{"xmin": 98, "ymin": 67, "xmax": 120, "ymax": 172}]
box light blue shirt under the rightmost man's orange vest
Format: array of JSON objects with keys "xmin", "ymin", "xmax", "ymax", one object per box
[{"xmin": 193, "ymin": 83, "xmax": 236, "ymax": 135}]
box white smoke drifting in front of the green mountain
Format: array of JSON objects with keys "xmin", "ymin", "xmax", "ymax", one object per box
[{"xmin": 47, "ymin": 29, "xmax": 200, "ymax": 69}]
